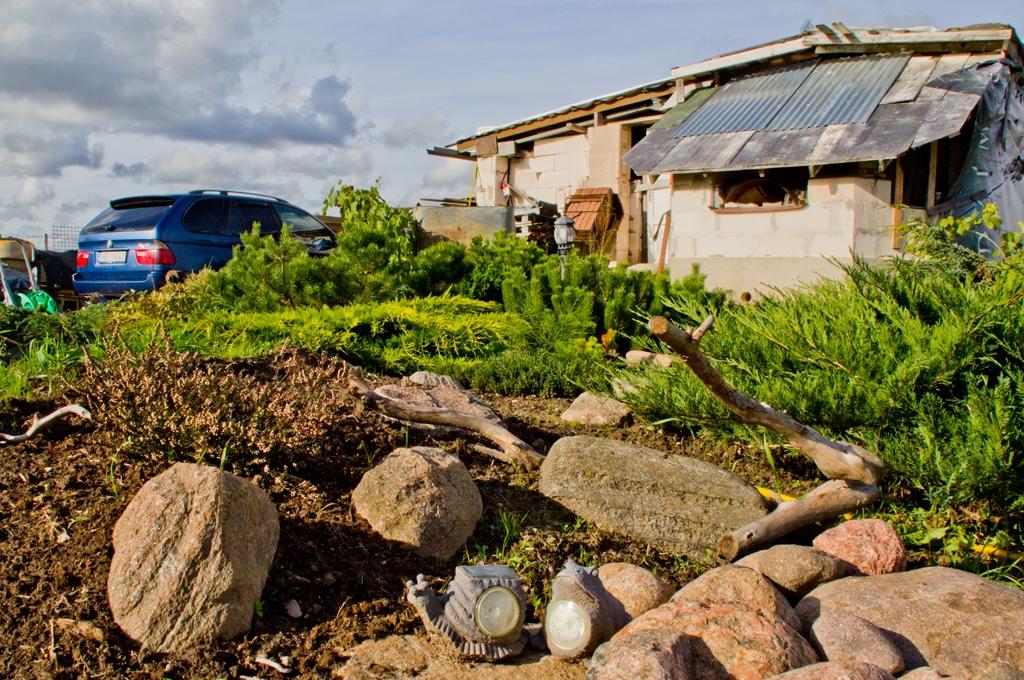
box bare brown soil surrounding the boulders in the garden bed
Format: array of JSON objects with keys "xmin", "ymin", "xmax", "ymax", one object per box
[{"xmin": 0, "ymin": 358, "xmax": 813, "ymax": 679}]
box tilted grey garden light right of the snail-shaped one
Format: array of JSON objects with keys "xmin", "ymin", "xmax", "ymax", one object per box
[{"xmin": 544, "ymin": 559, "xmax": 629, "ymax": 658}]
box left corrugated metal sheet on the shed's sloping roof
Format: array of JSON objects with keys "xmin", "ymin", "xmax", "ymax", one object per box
[{"xmin": 673, "ymin": 61, "xmax": 816, "ymax": 137}]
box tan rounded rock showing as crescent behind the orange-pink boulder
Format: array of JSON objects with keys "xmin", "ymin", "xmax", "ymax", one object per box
[{"xmin": 672, "ymin": 564, "xmax": 801, "ymax": 631}]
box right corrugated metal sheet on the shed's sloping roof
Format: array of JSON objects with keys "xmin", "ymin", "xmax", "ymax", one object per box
[{"xmin": 761, "ymin": 54, "xmax": 910, "ymax": 130}]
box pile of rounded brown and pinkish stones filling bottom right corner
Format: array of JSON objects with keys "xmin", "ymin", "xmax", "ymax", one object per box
[{"xmin": 587, "ymin": 520, "xmax": 1024, "ymax": 680}]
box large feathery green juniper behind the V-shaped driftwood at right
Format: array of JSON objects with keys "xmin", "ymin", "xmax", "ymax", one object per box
[{"xmin": 624, "ymin": 206, "xmax": 1024, "ymax": 509}]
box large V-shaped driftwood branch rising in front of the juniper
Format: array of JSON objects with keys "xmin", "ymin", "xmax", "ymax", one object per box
[{"xmin": 648, "ymin": 316, "xmax": 885, "ymax": 560}]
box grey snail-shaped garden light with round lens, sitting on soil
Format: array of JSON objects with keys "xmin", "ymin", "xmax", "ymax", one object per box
[{"xmin": 406, "ymin": 564, "xmax": 527, "ymax": 661}]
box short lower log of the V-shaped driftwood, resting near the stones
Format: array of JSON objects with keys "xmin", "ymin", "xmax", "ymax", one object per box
[{"xmin": 717, "ymin": 479, "xmax": 880, "ymax": 561}]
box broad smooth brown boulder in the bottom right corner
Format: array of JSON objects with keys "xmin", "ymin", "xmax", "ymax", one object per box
[{"xmin": 797, "ymin": 566, "xmax": 1024, "ymax": 678}]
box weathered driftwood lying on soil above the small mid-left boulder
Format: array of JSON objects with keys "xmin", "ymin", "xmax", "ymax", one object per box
[{"xmin": 348, "ymin": 375, "xmax": 544, "ymax": 470}]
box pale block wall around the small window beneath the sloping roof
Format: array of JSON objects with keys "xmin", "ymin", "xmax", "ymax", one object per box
[{"xmin": 667, "ymin": 175, "xmax": 898, "ymax": 295}]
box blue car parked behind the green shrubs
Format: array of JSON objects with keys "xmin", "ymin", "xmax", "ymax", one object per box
[{"xmin": 72, "ymin": 189, "xmax": 335, "ymax": 297}]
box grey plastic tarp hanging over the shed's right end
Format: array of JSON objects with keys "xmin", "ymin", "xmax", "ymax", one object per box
[{"xmin": 948, "ymin": 61, "xmax": 1024, "ymax": 251}]
